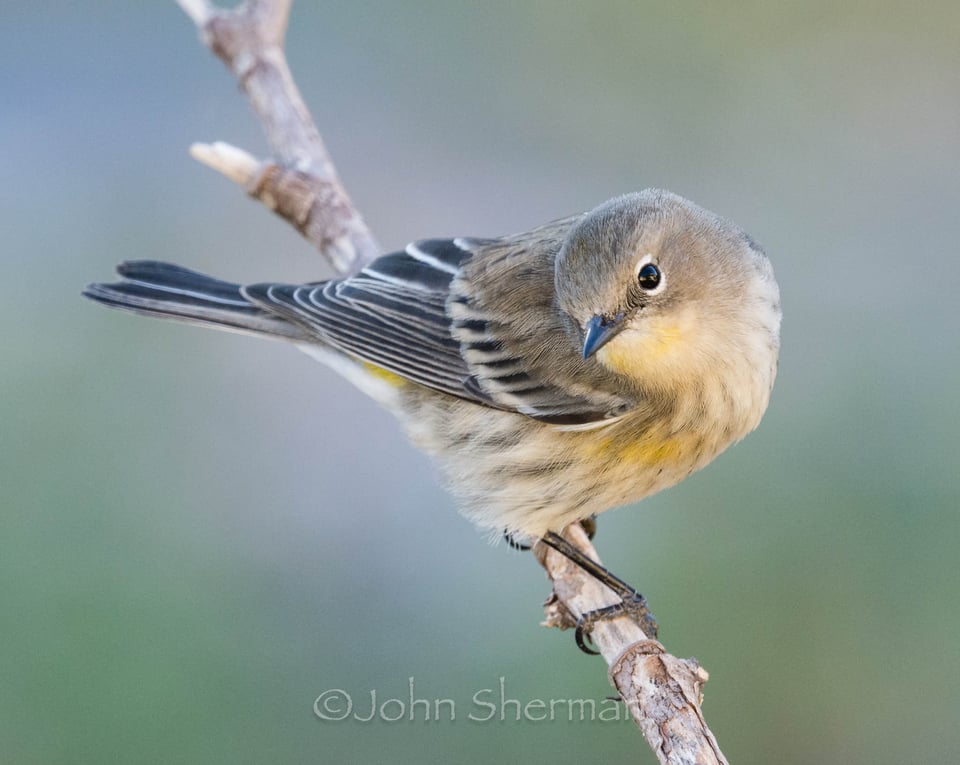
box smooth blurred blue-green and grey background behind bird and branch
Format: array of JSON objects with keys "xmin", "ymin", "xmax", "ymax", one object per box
[{"xmin": 0, "ymin": 0, "xmax": 960, "ymax": 765}]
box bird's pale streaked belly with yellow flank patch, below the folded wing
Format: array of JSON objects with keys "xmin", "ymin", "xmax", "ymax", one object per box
[{"xmin": 407, "ymin": 402, "xmax": 727, "ymax": 537}]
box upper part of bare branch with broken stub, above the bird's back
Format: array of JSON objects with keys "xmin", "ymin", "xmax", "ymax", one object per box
[{"xmin": 177, "ymin": 0, "xmax": 380, "ymax": 274}]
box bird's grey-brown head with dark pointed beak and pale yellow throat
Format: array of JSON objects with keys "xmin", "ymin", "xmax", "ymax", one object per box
[{"xmin": 555, "ymin": 190, "xmax": 780, "ymax": 406}]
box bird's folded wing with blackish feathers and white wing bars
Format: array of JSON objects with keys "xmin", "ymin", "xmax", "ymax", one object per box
[{"xmin": 243, "ymin": 233, "xmax": 627, "ymax": 425}]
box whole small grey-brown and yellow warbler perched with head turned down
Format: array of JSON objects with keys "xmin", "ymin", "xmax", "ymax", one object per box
[{"xmin": 85, "ymin": 190, "xmax": 780, "ymax": 636}]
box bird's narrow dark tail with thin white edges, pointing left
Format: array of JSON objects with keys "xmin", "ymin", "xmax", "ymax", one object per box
[{"xmin": 83, "ymin": 260, "xmax": 307, "ymax": 341}]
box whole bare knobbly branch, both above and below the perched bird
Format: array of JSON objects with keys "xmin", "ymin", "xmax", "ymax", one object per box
[{"xmin": 177, "ymin": 0, "xmax": 727, "ymax": 765}]
